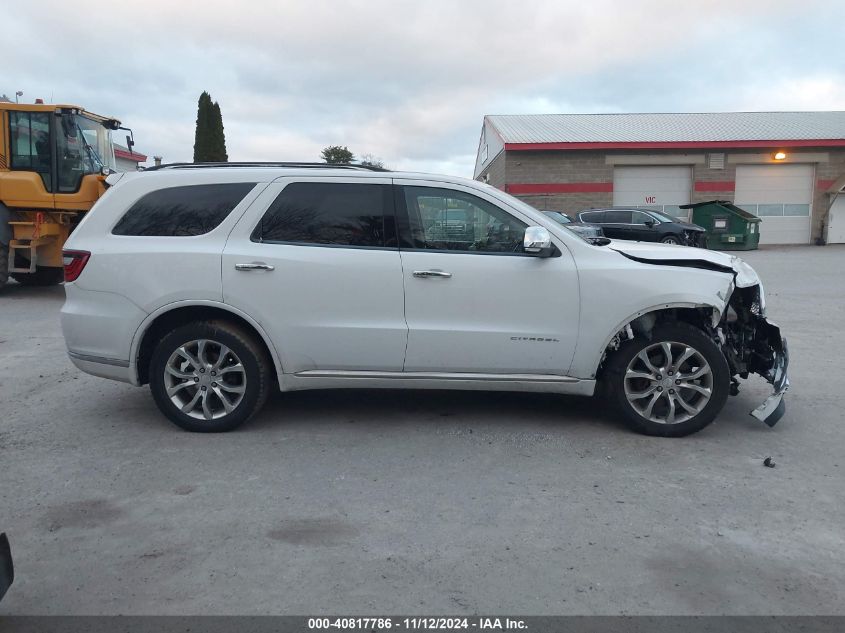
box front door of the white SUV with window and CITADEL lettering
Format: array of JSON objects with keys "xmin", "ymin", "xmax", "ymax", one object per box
[{"xmin": 394, "ymin": 180, "xmax": 579, "ymax": 375}]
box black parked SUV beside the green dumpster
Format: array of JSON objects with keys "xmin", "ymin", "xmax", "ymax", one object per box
[{"xmin": 578, "ymin": 209, "xmax": 704, "ymax": 246}]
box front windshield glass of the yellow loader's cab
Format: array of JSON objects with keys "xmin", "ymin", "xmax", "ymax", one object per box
[{"xmin": 57, "ymin": 114, "xmax": 115, "ymax": 193}]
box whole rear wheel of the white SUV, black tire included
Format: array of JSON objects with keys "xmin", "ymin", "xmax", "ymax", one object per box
[{"xmin": 149, "ymin": 321, "xmax": 272, "ymax": 433}]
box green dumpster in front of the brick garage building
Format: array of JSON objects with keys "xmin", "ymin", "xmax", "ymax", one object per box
[{"xmin": 681, "ymin": 200, "xmax": 761, "ymax": 251}]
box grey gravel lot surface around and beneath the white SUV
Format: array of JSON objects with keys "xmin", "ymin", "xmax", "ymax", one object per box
[{"xmin": 0, "ymin": 246, "xmax": 845, "ymax": 615}]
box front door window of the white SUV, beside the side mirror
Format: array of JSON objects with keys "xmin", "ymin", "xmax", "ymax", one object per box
[{"xmin": 403, "ymin": 187, "xmax": 527, "ymax": 253}]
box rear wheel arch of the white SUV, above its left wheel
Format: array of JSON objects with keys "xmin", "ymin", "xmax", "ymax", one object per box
[{"xmin": 129, "ymin": 300, "xmax": 283, "ymax": 386}]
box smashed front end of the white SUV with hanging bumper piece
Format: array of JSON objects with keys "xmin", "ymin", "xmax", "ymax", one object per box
[{"xmin": 717, "ymin": 283, "xmax": 789, "ymax": 426}]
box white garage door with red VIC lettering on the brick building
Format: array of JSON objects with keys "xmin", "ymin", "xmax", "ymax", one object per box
[{"xmin": 613, "ymin": 167, "xmax": 692, "ymax": 217}]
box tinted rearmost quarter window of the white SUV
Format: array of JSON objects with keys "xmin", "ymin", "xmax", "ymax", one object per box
[{"xmin": 112, "ymin": 182, "xmax": 255, "ymax": 237}]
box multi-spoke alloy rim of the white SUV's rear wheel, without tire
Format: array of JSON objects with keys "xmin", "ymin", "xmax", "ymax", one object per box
[{"xmin": 164, "ymin": 339, "xmax": 246, "ymax": 420}]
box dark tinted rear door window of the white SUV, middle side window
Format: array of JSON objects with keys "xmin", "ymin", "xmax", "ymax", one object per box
[{"xmin": 252, "ymin": 182, "xmax": 396, "ymax": 248}]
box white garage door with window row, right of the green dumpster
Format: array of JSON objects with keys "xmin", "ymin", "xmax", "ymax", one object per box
[{"xmin": 734, "ymin": 165, "xmax": 814, "ymax": 244}]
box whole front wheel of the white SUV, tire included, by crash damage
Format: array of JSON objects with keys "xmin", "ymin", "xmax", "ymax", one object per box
[{"xmin": 605, "ymin": 323, "xmax": 730, "ymax": 437}]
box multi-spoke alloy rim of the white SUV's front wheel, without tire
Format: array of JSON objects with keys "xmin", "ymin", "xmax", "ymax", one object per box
[{"xmin": 625, "ymin": 341, "xmax": 713, "ymax": 424}]
